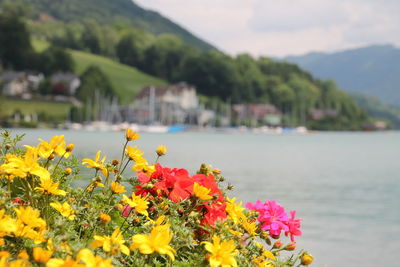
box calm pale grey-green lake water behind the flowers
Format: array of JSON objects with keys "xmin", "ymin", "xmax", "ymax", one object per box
[{"xmin": 9, "ymin": 130, "xmax": 400, "ymax": 267}]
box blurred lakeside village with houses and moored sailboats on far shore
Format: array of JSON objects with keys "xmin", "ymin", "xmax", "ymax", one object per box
[{"xmin": 0, "ymin": 68, "xmax": 385, "ymax": 131}]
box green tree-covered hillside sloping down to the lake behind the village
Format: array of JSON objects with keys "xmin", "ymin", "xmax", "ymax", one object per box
[{"xmin": 0, "ymin": 0, "xmax": 369, "ymax": 130}]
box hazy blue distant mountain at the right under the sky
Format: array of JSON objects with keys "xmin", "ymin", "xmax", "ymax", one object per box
[{"xmin": 284, "ymin": 45, "xmax": 400, "ymax": 105}]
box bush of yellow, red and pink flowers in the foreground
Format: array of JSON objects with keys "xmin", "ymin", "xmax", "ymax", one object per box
[{"xmin": 0, "ymin": 129, "xmax": 313, "ymax": 267}]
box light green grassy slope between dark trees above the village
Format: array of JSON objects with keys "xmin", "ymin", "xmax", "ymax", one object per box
[{"xmin": 32, "ymin": 40, "xmax": 167, "ymax": 104}]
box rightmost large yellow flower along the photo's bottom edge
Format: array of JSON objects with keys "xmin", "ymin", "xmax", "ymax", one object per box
[{"xmin": 202, "ymin": 235, "xmax": 237, "ymax": 267}]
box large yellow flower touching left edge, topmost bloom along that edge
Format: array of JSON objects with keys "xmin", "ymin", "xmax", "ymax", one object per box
[{"xmin": 0, "ymin": 147, "xmax": 50, "ymax": 181}]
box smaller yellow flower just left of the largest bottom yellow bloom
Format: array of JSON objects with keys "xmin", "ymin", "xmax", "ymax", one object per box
[{"xmin": 92, "ymin": 228, "xmax": 129, "ymax": 255}]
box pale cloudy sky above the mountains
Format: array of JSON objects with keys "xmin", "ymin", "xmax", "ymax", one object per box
[{"xmin": 134, "ymin": 0, "xmax": 400, "ymax": 57}]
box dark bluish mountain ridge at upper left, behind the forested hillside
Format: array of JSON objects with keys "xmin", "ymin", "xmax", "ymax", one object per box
[{"xmin": 0, "ymin": 0, "xmax": 215, "ymax": 50}]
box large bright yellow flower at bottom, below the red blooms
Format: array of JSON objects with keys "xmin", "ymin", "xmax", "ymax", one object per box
[{"xmin": 131, "ymin": 224, "xmax": 176, "ymax": 261}]
